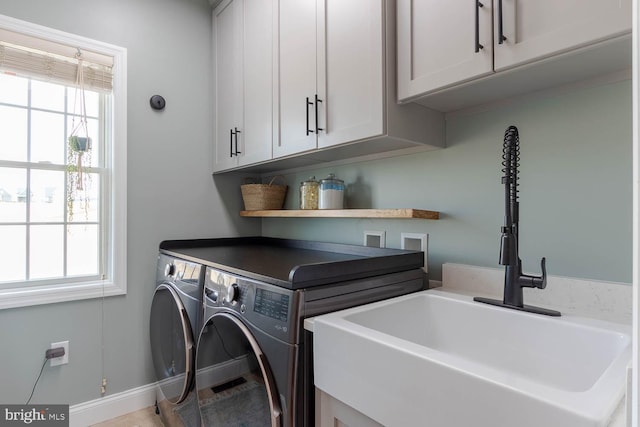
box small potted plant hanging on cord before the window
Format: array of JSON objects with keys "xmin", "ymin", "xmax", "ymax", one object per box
[{"xmin": 67, "ymin": 49, "xmax": 91, "ymax": 221}]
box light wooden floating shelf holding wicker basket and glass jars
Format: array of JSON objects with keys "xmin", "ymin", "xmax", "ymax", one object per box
[{"xmin": 240, "ymin": 209, "xmax": 440, "ymax": 219}]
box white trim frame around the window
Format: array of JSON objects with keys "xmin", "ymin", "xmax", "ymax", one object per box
[{"xmin": 0, "ymin": 15, "xmax": 127, "ymax": 309}]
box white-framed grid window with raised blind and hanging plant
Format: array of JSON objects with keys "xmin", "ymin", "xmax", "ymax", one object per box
[{"xmin": 0, "ymin": 15, "xmax": 126, "ymax": 308}]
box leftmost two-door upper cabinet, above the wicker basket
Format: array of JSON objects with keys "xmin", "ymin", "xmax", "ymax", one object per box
[{"xmin": 213, "ymin": 0, "xmax": 274, "ymax": 171}]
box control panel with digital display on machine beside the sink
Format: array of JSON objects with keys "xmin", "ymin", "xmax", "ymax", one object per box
[{"xmin": 204, "ymin": 267, "xmax": 296, "ymax": 342}]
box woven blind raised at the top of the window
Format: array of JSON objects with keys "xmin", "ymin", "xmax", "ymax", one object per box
[{"xmin": 0, "ymin": 29, "xmax": 113, "ymax": 92}]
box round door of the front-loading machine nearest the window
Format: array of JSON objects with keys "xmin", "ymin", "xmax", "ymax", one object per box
[{"xmin": 149, "ymin": 283, "xmax": 195, "ymax": 403}]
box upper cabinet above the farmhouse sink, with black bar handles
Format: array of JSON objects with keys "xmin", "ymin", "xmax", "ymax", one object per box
[{"xmin": 398, "ymin": 0, "xmax": 632, "ymax": 111}]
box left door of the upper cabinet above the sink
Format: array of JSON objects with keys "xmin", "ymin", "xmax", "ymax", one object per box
[{"xmin": 397, "ymin": 0, "xmax": 496, "ymax": 100}]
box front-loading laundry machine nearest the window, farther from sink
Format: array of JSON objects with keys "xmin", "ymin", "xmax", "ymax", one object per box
[{"xmin": 149, "ymin": 254, "xmax": 205, "ymax": 427}]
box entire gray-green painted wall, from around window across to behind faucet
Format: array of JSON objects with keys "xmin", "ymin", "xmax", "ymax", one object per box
[{"xmin": 0, "ymin": 0, "xmax": 631, "ymax": 412}]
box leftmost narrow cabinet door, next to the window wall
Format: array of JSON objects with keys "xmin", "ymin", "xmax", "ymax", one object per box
[{"xmin": 213, "ymin": 0, "xmax": 242, "ymax": 171}]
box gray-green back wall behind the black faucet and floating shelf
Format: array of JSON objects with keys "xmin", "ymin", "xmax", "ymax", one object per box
[{"xmin": 263, "ymin": 81, "xmax": 632, "ymax": 283}]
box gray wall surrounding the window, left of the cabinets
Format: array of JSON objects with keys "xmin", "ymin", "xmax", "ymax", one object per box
[{"xmin": 0, "ymin": 0, "xmax": 260, "ymax": 404}]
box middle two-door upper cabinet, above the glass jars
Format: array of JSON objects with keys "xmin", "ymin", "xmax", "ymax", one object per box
[{"xmin": 273, "ymin": 0, "xmax": 444, "ymax": 161}]
